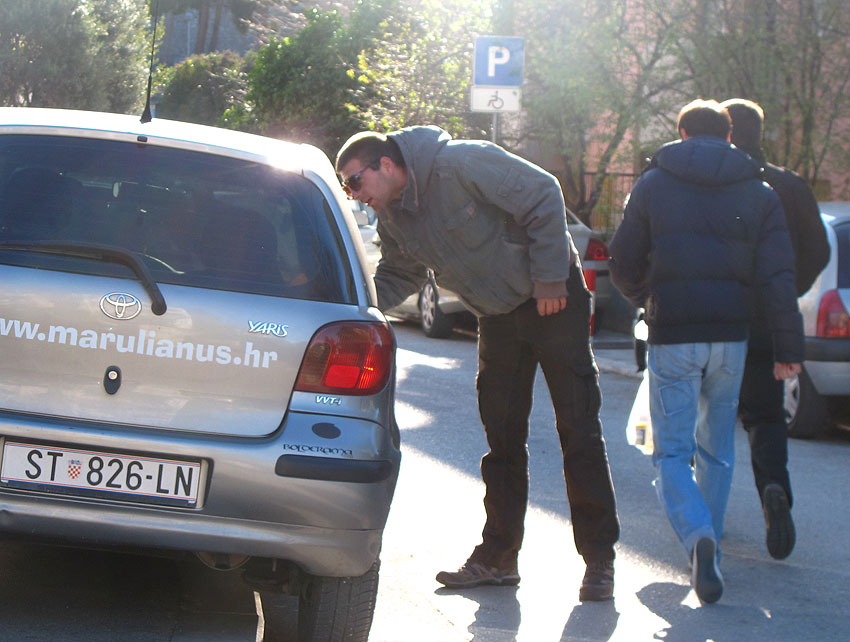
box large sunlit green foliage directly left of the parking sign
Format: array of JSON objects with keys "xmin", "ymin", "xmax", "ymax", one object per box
[{"xmin": 232, "ymin": 0, "xmax": 489, "ymax": 155}]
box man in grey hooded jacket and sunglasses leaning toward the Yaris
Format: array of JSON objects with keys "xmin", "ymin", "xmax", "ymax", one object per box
[{"xmin": 336, "ymin": 127, "xmax": 619, "ymax": 600}]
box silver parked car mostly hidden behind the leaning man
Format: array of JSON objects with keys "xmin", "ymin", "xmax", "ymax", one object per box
[{"xmin": 352, "ymin": 201, "xmax": 611, "ymax": 338}]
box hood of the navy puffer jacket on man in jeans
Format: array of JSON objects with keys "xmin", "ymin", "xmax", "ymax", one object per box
[{"xmin": 654, "ymin": 136, "xmax": 761, "ymax": 187}]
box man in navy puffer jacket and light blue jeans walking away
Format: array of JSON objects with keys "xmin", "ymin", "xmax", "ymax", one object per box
[{"xmin": 609, "ymin": 100, "xmax": 803, "ymax": 602}]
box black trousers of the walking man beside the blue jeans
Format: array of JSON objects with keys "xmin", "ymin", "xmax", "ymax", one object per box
[{"xmin": 738, "ymin": 323, "xmax": 792, "ymax": 502}]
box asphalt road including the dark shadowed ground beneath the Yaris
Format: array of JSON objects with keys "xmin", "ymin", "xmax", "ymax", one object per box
[{"xmin": 0, "ymin": 324, "xmax": 850, "ymax": 642}]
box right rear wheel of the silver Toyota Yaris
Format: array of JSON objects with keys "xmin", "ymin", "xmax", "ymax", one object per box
[{"xmin": 298, "ymin": 562, "xmax": 379, "ymax": 642}]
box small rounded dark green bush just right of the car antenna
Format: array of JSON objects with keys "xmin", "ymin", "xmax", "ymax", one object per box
[{"xmin": 156, "ymin": 51, "xmax": 253, "ymax": 125}]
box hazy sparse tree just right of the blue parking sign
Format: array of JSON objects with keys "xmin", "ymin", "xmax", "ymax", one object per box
[{"xmin": 500, "ymin": 0, "xmax": 682, "ymax": 221}]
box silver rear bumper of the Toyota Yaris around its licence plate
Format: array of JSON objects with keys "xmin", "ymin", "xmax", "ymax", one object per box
[{"xmin": 0, "ymin": 412, "xmax": 400, "ymax": 576}]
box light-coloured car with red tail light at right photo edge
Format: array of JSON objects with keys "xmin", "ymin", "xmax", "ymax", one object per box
[{"xmin": 785, "ymin": 202, "xmax": 850, "ymax": 438}]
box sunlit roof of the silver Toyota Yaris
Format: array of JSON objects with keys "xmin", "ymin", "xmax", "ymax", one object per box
[{"xmin": 0, "ymin": 107, "xmax": 336, "ymax": 184}]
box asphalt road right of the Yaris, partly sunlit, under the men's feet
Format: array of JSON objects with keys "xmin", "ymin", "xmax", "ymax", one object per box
[{"xmin": 370, "ymin": 326, "xmax": 850, "ymax": 642}]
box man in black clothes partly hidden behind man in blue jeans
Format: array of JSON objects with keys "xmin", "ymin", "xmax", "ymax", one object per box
[{"xmin": 722, "ymin": 98, "xmax": 829, "ymax": 559}]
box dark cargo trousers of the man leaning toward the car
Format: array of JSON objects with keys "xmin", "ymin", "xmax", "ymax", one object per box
[{"xmin": 471, "ymin": 266, "xmax": 620, "ymax": 568}]
